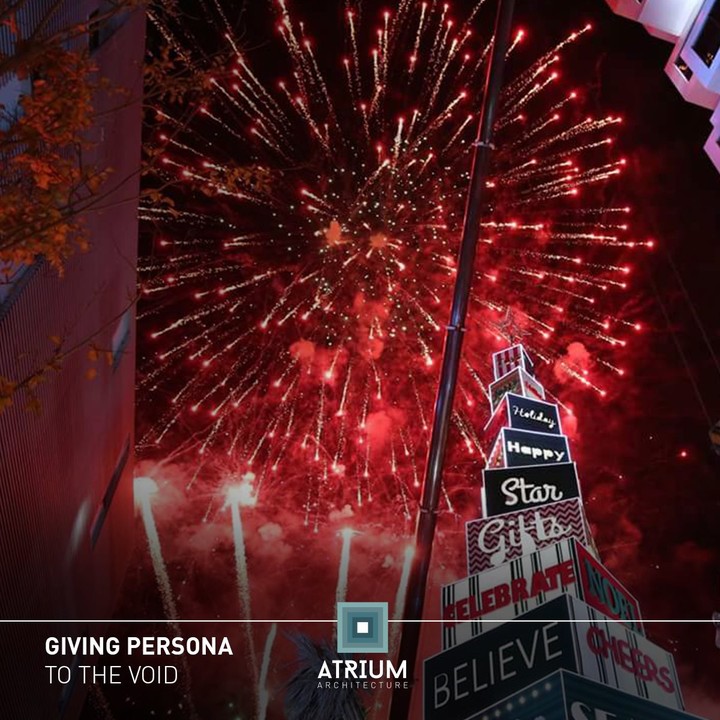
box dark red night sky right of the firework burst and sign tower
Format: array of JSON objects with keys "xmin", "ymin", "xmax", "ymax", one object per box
[{"xmin": 518, "ymin": 0, "xmax": 720, "ymax": 718}]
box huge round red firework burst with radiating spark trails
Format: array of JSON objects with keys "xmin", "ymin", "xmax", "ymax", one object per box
[{"xmin": 141, "ymin": 0, "xmax": 649, "ymax": 530}]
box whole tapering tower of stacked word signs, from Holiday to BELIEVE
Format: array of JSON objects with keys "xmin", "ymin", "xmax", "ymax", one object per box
[{"xmin": 423, "ymin": 344, "xmax": 704, "ymax": 720}]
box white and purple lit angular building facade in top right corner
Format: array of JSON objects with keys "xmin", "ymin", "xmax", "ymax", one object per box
[{"xmin": 607, "ymin": 0, "xmax": 720, "ymax": 171}]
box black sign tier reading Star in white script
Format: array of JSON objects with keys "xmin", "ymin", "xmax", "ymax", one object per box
[{"xmin": 482, "ymin": 463, "xmax": 580, "ymax": 517}]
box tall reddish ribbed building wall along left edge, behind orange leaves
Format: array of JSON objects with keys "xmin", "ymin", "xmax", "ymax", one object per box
[{"xmin": 0, "ymin": 0, "xmax": 145, "ymax": 720}]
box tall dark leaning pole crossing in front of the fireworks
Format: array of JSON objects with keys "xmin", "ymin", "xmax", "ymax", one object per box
[{"xmin": 390, "ymin": 0, "xmax": 515, "ymax": 720}]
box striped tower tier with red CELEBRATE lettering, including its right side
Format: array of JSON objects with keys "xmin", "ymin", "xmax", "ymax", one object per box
[{"xmin": 441, "ymin": 539, "xmax": 642, "ymax": 648}]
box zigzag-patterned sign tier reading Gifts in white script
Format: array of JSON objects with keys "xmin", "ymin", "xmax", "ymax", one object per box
[{"xmin": 465, "ymin": 498, "xmax": 590, "ymax": 575}]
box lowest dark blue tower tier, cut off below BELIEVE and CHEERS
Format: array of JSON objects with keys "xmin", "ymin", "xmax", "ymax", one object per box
[{"xmin": 464, "ymin": 670, "xmax": 699, "ymax": 720}]
